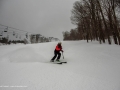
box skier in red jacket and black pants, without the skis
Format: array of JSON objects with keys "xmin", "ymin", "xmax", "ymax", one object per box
[{"xmin": 51, "ymin": 42, "xmax": 63, "ymax": 62}]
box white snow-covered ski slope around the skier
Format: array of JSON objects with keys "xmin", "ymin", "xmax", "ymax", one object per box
[{"xmin": 0, "ymin": 41, "xmax": 120, "ymax": 90}]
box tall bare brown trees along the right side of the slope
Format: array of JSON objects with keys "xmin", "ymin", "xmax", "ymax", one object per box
[{"xmin": 63, "ymin": 0, "xmax": 120, "ymax": 45}]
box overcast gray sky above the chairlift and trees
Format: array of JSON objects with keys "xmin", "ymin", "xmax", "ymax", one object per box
[{"xmin": 0, "ymin": 0, "xmax": 76, "ymax": 40}]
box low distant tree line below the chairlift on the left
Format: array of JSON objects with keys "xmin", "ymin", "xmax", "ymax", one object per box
[{"xmin": 0, "ymin": 34, "xmax": 59, "ymax": 45}]
